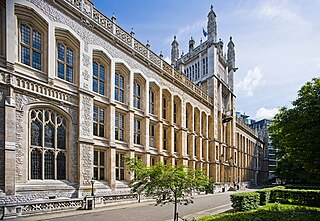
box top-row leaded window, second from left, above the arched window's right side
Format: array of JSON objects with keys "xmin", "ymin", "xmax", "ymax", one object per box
[{"xmin": 57, "ymin": 43, "xmax": 74, "ymax": 83}]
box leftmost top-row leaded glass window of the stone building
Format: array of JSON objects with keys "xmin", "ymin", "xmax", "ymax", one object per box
[{"xmin": 20, "ymin": 23, "xmax": 43, "ymax": 70}]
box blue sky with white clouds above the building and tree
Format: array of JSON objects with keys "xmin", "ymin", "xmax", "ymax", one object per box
[{"xmin": 93, "ymin": 0, "xmax": 320, "ymax": 119}]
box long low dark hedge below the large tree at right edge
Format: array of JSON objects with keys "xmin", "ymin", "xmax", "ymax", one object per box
[{"xmin": 270, "ymin": 189, "xmax": 320, "ymax": 207}]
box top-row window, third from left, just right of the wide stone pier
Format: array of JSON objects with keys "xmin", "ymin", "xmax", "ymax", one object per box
[{"xmin": 92, "ymin": 61, "xmax": 106, "ymax": 95}]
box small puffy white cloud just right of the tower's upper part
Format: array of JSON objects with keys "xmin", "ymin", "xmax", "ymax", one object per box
[{"xmin": 236, "ymin": 66, "xmax": 264, "ymax": 97}]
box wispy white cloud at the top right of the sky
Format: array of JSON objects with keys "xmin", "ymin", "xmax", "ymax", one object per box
[{"xmin": 255, "ymin": 1, "xmax": 311, "ymax": 26}]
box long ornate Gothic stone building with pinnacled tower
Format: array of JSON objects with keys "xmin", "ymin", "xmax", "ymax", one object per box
[{"xmin": 0, "ymin": 0, "xmax": 267, "ymax": 216}]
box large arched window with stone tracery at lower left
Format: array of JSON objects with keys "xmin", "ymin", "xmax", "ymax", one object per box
[{"xmin": 29, "ymin": 109, "xmax": 67, "ymax": 180}]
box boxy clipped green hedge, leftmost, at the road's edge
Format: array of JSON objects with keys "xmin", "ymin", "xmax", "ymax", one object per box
[{"xmin": 230, "ymin": 192, "xmax": 260, "ymax": 211}]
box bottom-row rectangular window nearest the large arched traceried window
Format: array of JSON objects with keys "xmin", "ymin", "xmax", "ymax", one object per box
[{"xmin": 93, "ymin": 149, "xmax": 106, "ymax": 180}]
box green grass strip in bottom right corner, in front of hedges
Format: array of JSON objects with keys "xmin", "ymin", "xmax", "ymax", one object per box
[{"xmin": 197, "ymin": 203, "xmax": 320, "ymax": 221}]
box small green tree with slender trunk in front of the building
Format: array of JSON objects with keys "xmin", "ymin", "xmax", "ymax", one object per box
[{"xmin": 127, "ymin": 158, "xmax": 210, "ymax": 221}]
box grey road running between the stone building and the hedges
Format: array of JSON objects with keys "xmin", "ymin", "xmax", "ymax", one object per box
[{"xmin": 16, "ymin": 192, "xmax": 235, "ymax": 221}]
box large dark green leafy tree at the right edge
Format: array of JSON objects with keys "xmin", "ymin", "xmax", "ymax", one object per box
[{"xmin": 269, "ymin": 78, "xmax": 320, "ymax": 183}]
